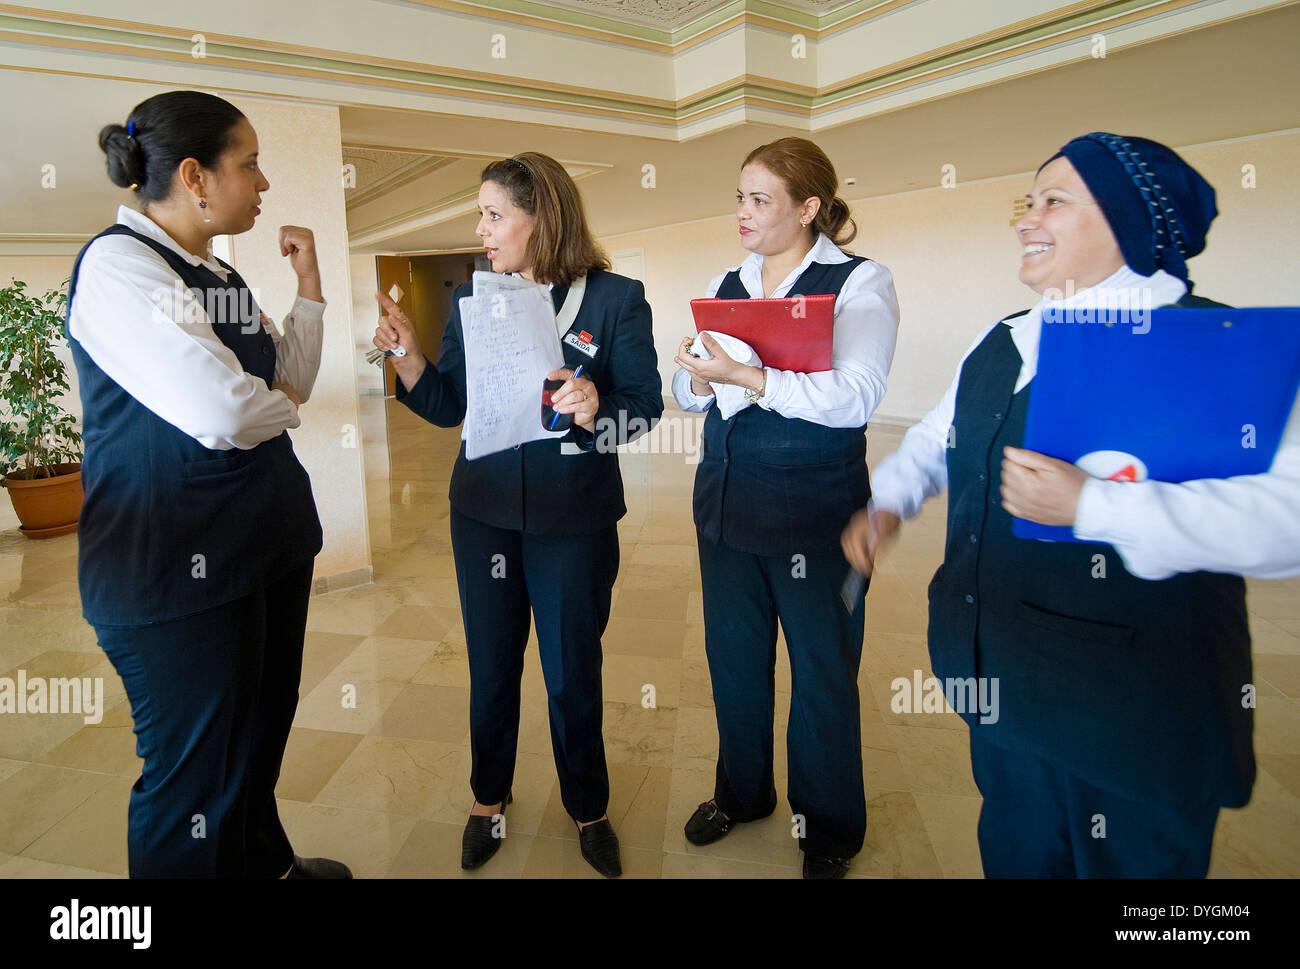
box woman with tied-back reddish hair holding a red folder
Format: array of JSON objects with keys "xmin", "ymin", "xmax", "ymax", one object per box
[{"xmin": 672, "ymin": 138, "xmax": 898, "ymax": 878}]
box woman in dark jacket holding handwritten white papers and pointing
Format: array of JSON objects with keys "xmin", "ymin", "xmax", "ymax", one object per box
[{"xmin": 374, "ymin": 152, "xmax": 663, "ymax": 877}]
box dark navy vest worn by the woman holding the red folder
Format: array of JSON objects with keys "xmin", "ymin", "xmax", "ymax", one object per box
[{"xmin": 694, "ymin": 256, "xmax": 871, "ymax": 555}]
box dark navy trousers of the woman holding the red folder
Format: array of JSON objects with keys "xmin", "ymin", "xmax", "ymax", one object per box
[{"xmin": 697, "ymin": 533, "xmax": 867, "ymax": 857}]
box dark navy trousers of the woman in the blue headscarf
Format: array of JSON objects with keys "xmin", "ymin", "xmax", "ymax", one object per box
[{"xmin": 971, "ymin": 727, "xmax": 1219, "ymax": 878}]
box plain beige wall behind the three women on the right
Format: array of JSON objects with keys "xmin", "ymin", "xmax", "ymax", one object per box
[{"xmin": 602, "ymin": 131, "xmax": 1300, "ymax": 424}]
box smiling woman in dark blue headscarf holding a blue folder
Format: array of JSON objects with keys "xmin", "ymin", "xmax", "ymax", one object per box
[{"xmin": 844, "ymin": 133, "xmax": 1300, "ymax": 877}]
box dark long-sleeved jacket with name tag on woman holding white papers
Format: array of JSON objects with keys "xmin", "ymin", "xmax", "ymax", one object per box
[{"xmin": 397, "ymin": 269, "xmax": 663, "ymax": 535}]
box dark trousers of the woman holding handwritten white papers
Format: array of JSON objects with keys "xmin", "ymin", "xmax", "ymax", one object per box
[{"xmin": 451, "ymin": 509, "xmax": 619, "ymax": 823}]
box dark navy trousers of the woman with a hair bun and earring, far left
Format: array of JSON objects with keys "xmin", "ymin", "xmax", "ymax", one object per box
[{"xmin": 95, "ymin": 562, "xmax": 312, "ymax": 878}]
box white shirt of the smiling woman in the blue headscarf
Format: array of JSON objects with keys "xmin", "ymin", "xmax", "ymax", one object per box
[{"xmin": 870, "ymin": 267, "xmax": 1300, "ymax": 579}]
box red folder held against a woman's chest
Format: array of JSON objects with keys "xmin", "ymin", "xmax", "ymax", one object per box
[{"xmin": 690, "ymin": 295, "xmax": 835, "ymax": 373}]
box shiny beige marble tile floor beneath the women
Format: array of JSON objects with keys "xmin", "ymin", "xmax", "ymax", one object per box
[{"xmin": 0, "ymin": 398, "xmax": 1300, "ymax": 878}]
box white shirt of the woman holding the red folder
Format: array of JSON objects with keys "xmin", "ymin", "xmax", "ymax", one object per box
[{"xmin": 672, "ymin": 233, "xmax": 898, "ymax": 428}]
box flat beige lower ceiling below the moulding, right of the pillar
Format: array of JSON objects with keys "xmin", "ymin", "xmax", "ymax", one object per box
[{"xmin": 342, "ymin": 7, "xmax": 1300, "ymax": 252}]
